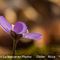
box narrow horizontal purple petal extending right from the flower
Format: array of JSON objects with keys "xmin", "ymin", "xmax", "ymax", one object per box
[{"xmin": 23, "ymin": 33, "xmax": 42, "ymax": 40}]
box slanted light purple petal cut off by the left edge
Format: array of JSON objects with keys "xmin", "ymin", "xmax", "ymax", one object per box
[{"xmin": 0, "ymin": 16, "xmax": 12, "ymax": 32}]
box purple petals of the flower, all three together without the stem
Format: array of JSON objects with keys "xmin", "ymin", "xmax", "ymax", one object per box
[{"xmin": 0, "ymin": 16, "xmax": 41, "ymax": 40}]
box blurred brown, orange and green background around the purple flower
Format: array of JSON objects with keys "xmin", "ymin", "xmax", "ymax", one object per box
[{"xmin": 0, "ymin": 0, "xmax": 60, "ymax": 60}]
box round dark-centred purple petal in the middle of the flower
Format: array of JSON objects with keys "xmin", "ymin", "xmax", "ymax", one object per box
[{"xmin": 13, "ymin": 22, "xmax": 27, "ymax": 34}]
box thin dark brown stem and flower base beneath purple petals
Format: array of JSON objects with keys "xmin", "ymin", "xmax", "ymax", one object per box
[{"xmin": 8, "ymin": 31, "xmax": 22, "ymax": 60}]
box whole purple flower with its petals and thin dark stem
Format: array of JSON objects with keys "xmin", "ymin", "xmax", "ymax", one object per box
[{"xmin": 0, "ymin": 16, "xmax": 41, "ymax": 60}]
